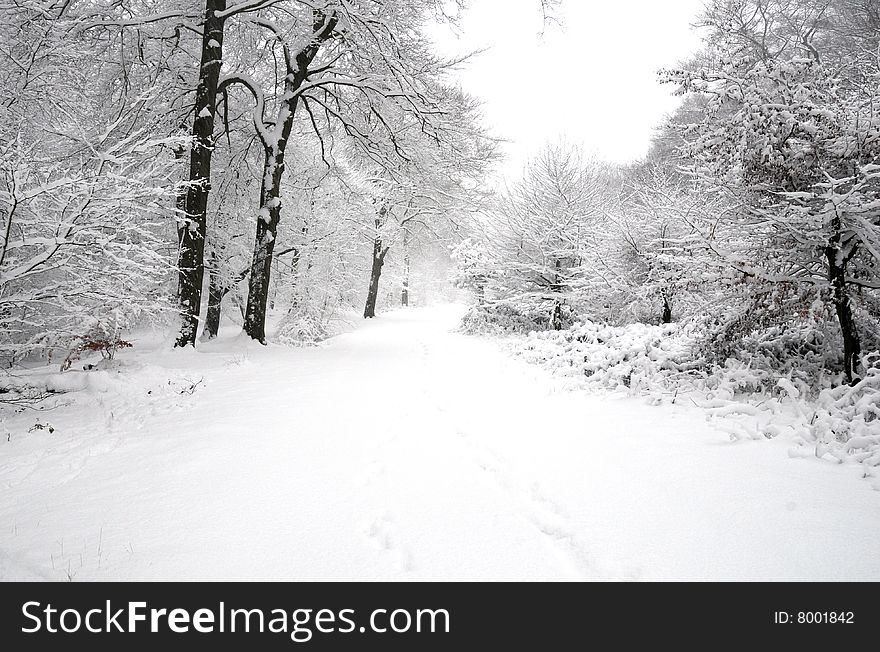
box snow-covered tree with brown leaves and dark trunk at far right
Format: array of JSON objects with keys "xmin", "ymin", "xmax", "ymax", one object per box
[{"xmin": 668, "ymin": 0, "xmax": 880, "ymax": 381}]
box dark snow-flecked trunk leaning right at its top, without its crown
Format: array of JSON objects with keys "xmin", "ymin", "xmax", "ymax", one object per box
[{"xmin": 244, "ymin": 10, "xmax": 338, "ymax": 344}]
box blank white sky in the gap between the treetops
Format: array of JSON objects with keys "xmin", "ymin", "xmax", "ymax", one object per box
[{"xmin": 435, "ymin": 0, "xmax": 703, "ymax": 177}]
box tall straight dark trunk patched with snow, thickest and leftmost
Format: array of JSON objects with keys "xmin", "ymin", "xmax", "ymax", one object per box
[{"xmin": 175, "ymin": 0, "xmax": 226, "ymax": 346}]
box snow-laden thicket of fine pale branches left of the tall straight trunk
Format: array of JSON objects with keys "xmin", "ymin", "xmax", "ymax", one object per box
[{"xmin": 0, "ymin": 2, "xmax": 183, "ymax": 364}]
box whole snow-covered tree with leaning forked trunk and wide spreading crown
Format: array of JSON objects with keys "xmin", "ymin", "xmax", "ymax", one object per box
[{"xmin": 207, "ymin": 0, "xmax": 484, "ymax": 342}]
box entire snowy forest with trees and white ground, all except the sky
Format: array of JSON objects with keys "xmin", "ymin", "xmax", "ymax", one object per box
[{"xmin": 0, "ymin": 0, "xmax": 880, "ymax": 581}]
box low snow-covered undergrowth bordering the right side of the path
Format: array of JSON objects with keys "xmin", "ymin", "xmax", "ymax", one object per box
[{"xmin": 508, "ymin": 321, "xmax": 880, "ymax": 477}]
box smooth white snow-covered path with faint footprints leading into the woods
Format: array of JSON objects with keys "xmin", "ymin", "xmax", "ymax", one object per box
[{"xmin": 0, "ymin": 307, "xmax": 880, "ymax": 581}]
